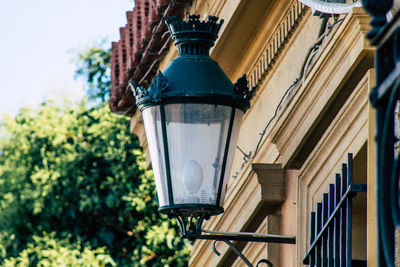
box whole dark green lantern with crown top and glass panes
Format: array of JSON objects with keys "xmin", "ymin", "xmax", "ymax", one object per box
[{"xmin": 131, "ymin": 15, "xmax": 253, "ymax": 224}]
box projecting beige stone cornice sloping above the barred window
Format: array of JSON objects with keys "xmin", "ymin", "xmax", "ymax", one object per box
[{"xmin": 270, "ymin": 8, "xmax": 373, "ymax": 167}]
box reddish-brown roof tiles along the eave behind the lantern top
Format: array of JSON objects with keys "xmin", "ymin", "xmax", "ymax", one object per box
[{"xmin": 109, "ymin": 0, "xmax": 190, "ymax": 115}]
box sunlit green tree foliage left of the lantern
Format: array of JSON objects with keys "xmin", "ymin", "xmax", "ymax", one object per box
[{"xmin": 0, "ymin": 100, "xmax": 190, "ymax": 266}]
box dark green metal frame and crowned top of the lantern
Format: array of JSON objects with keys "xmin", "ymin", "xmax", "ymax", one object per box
[{"xmin": 131, "ymin": 15, "xmax": 254, "ymax": 220}]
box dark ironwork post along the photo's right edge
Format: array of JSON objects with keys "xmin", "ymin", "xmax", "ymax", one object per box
[{"xmin": 363, "ymin": 0, "xmax": 400, "ymax": 267}]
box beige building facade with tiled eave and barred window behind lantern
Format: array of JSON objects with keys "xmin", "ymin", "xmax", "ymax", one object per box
[{"xmin": 110, "ymin": 0, "xmax": 377, "ymax": 267}]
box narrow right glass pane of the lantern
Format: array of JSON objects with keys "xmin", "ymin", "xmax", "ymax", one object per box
[{"xmin": 219, "ymin": 109, "xmax": 243, "ymax": 207}]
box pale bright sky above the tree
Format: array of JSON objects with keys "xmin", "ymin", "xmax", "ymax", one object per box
[{"xmin": 0, "ymin": 0, "xmax": 134, "ymax": 115}]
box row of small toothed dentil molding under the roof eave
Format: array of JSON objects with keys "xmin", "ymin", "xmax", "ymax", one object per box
[{"xmin": 249, "ymin": 0, "xmax": 309, "ymax": 88}]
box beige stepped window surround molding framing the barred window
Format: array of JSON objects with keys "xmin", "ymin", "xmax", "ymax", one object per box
[{"xmin": 297, "ymin": 70, "xmax": 374, "ymax": 263}]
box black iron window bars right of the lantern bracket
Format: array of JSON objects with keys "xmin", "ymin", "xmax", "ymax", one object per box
[{"xmin": 303, "ymin": 154, "xmax": 367, "ymax": 267}]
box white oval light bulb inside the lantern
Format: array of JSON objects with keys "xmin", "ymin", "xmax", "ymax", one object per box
[{"xmin": 183, "ymin": 160, "xmax": 203, "ymax": 195}]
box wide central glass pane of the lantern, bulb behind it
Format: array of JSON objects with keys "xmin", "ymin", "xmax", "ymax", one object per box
[{"xmin": 165, "ymin": 103, "xmax": 239, "ymax": 205}]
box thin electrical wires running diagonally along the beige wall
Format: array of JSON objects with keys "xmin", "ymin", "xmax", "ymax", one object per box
[{"xmin": 233, "ymin": 16, "xmax": 344, "ymax": 179}]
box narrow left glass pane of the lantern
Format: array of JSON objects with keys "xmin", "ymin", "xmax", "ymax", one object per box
[{"xmin": 143, "ymin": 106, "xmax": 169, "ymax": 206}]
